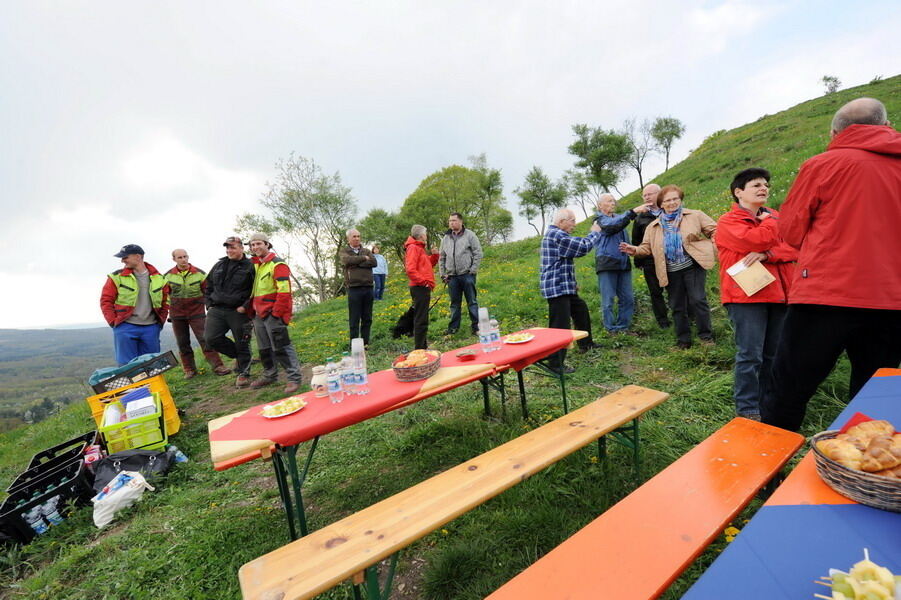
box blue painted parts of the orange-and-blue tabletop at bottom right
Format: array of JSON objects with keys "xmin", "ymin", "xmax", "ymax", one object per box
[{"xmin": 683, "ymin": 376, "xmax": 901, "ymax": 600}]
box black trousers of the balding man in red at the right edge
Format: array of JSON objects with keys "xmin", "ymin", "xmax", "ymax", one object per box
[{"xmin": 760, "ymin": 304, "xmax": 901, "ymax": 431}]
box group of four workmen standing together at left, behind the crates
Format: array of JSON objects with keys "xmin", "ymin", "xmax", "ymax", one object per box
[{"xmin": 100, "ymin": 233, "xmax": 301, "ymax": 394}]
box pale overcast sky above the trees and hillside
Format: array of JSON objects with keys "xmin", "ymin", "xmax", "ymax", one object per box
[{"xmin": 0, "ymin": 0, "xmax": 901, "ymax": 328}]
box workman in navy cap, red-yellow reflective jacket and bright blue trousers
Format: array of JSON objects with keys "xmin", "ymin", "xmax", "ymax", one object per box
[{"xmin": 100, "ymin": 244, "xmax": 169, "ymax": 365}]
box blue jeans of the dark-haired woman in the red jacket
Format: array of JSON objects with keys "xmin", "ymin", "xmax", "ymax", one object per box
[{"xmin": 725, "ymin": 302, "xmax": 788, "ymax": 416}]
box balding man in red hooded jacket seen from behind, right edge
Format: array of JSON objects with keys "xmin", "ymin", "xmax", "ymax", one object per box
[{"xmin": 761, "ymin": 98, "xmax": 901, "ymax": 430}]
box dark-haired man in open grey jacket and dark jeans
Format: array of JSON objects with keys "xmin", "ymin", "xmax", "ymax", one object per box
[{"xmin": 438, "ymin": 213, "xmax": 482, "ymax": 335}]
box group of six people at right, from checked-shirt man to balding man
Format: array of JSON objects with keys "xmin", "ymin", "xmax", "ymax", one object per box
[{"xmin": 540, "ymin": 98, "xmax": 901, "ymax": 430}]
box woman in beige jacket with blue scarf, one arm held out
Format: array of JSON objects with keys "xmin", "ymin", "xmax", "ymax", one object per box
[{"xmin": 620, "ymin": 185, "xmax": 716, "ymax": 349}]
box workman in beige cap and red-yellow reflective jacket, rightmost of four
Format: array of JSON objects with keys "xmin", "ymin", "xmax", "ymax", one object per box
[{"xmin": 249, "ymin": 233, "xmax": 301, "ymax": 394}]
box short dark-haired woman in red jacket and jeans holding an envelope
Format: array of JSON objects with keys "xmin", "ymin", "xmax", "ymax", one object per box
[{"xmin": 716, "ymin": 168, "xmax": 798, "ymax": 421}]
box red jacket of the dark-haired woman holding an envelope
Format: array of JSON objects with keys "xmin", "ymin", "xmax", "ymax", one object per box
[{"xmin": 715, "ymin": 203, "xmax": 798, "ymax": 304}]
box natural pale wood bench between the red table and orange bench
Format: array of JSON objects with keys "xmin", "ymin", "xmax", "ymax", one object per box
[{"xmin": 239, "ymin": 385, "xmax": 668, "ymax": 600}]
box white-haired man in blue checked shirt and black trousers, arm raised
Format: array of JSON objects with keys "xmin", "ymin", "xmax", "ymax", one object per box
[{"xmin": 539, "ymin": 208, "xmax": 601, "ymax": 373}]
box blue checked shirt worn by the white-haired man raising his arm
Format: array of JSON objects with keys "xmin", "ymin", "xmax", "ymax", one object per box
[{"xmin": 538, "ymin": 225, "xmax": 601, "ymax": 298}]
